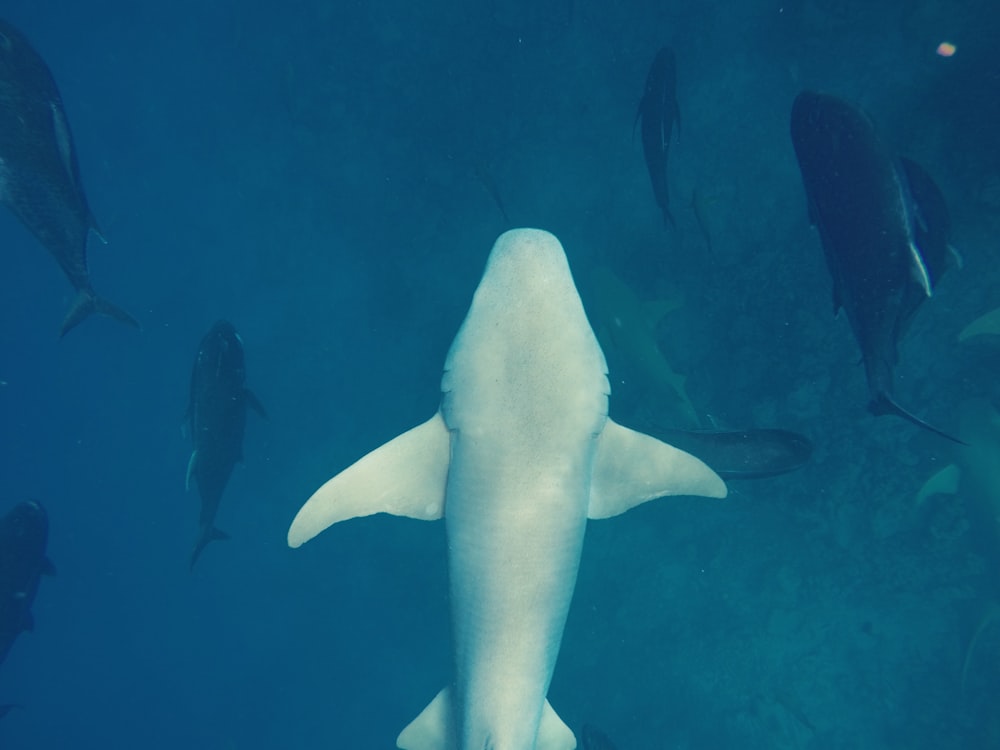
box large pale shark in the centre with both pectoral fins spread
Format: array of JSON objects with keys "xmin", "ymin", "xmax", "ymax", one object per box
[{"xmin": 288, "ymin": 229, "xmax": 726, "ymax": 750}]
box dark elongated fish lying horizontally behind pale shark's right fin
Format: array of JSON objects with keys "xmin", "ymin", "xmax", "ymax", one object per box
[{"xmin": 650, "ymin": 428, "xmax": 813, "ymax": 480}]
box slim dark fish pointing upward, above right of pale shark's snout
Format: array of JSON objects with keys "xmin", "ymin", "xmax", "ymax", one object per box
[{"xmin": 635, "ymin": 47, "xmax": 681, "ymax": 225}]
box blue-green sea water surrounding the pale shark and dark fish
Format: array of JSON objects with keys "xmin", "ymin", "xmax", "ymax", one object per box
[{"xmin": 0, "ymin": 0, "xmax": 1000, "ymax": 750}]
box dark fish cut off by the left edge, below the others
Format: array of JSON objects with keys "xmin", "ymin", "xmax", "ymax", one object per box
[{"xmin": 0, "ymin": 500, "xmax": 55, "ymax": 663}]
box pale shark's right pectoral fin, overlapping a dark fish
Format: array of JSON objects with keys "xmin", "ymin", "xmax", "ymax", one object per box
[{"xmin": 587, "ymin": 419, "xmax": 726, "ymax": 518}]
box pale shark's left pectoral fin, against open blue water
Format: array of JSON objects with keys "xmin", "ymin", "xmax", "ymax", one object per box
[{"xmin": 288, "ymin": 412, "xmax": 451, "ymax": 547}]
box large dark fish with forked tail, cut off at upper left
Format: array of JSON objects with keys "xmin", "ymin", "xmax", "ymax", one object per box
[{"xmin": 0, "ymin": 20, "xmax": 139, "ymax": 336}]
